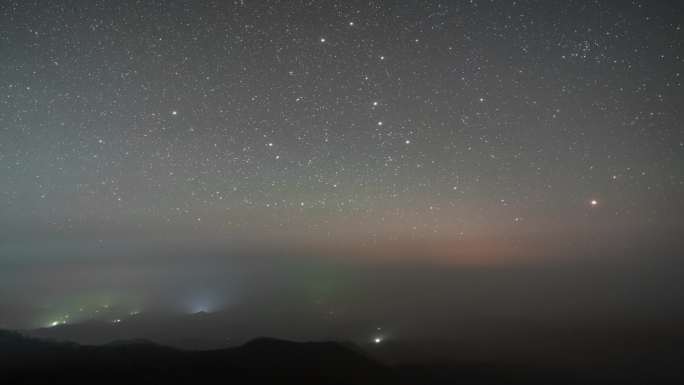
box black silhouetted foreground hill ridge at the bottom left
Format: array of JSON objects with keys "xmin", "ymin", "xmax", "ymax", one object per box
[{"xmin": 0, "ymin": 331, "xmax": 393, "ymax": 384}]
